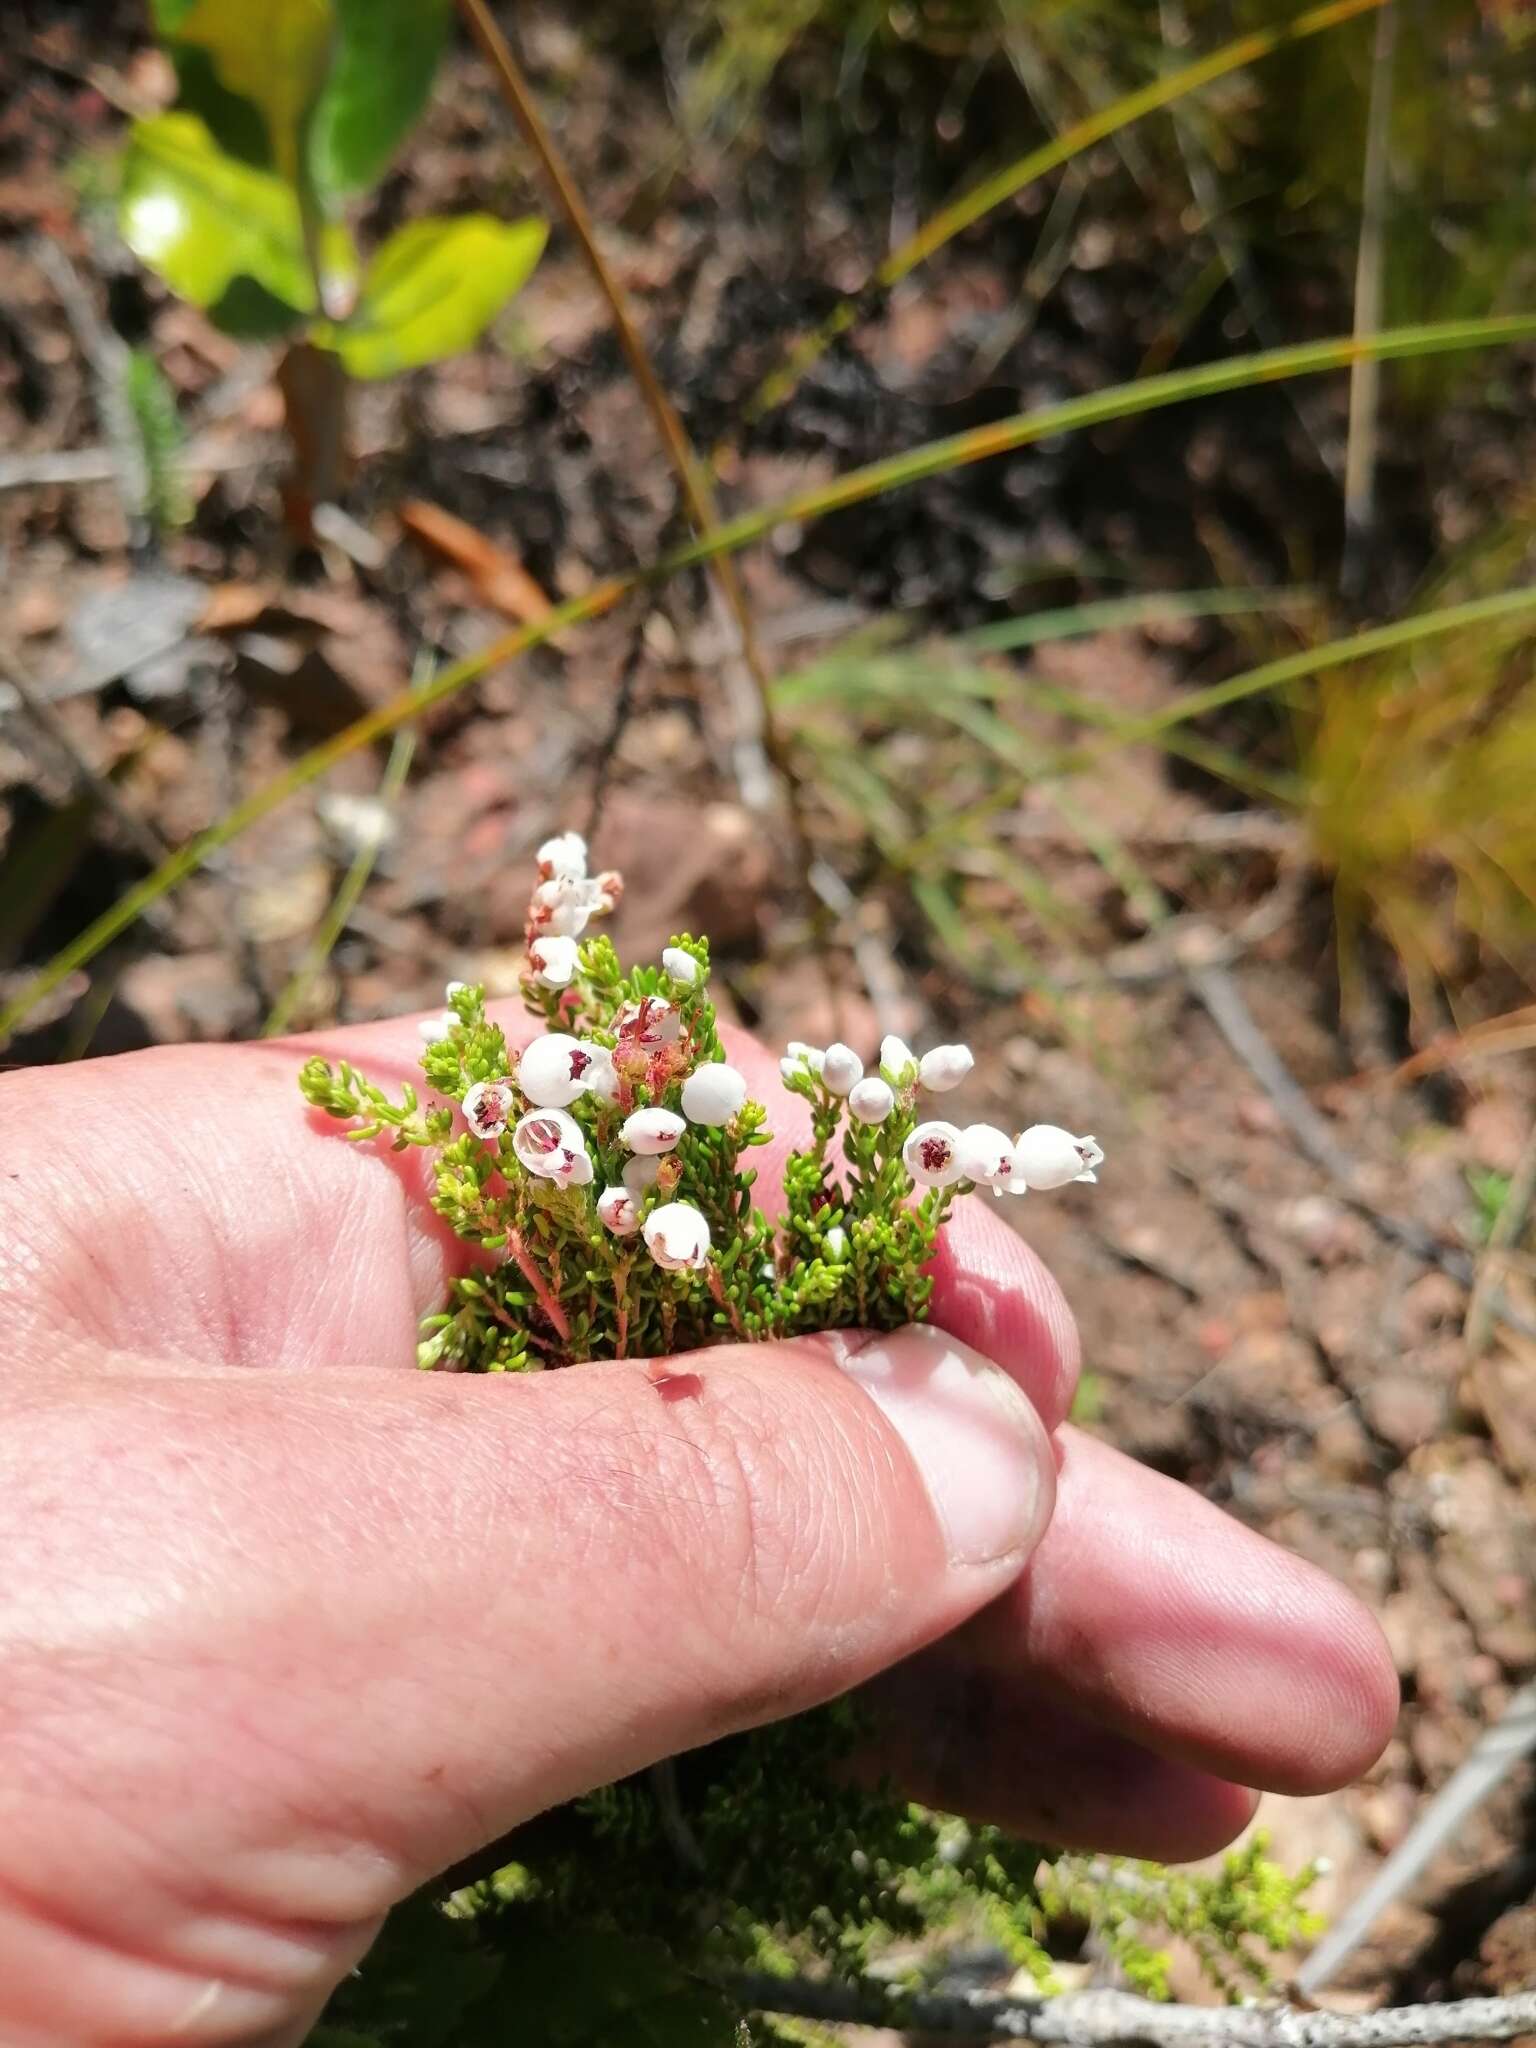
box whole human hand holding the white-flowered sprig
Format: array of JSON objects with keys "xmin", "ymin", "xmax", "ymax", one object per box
[{"xmin": 0, "ymin": 1020, "xmax": 1397, "ymax": 2048}]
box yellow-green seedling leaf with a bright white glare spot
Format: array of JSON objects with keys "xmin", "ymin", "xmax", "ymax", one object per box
[{"xmin": 119, "ymin": 113, "xmax": 356, "ymax": 326}]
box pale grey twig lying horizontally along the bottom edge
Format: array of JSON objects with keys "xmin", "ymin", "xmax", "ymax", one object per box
[{"xmin": 725, "ymin": 1974, "xmax": 1536, "ymax": 2048}]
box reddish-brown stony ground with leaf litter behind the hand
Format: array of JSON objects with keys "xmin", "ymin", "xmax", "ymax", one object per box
[{"xmin": 0, "ymin": 6, "xmax": 1536, "ymax": 2001}]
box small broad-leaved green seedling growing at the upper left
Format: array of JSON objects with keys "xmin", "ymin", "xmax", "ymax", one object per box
[{"xmin": 119, "ymin": 0, "xmax": 545, "ymax": 377}]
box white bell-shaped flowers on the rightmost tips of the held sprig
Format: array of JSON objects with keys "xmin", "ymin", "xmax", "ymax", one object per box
[{"xmin": 778, "ymin": 1034, "xmax": 1104, "ymax": 1194}]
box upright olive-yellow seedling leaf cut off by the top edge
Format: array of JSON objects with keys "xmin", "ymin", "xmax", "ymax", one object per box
[{"xmin": 176, "ymin": 0, "xmax": 336, "ymax": 180}]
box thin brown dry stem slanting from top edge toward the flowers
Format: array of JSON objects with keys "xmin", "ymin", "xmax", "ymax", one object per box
[{"xmin": 459, "ymin": 0, "xmax": 836, "ymax": 962}]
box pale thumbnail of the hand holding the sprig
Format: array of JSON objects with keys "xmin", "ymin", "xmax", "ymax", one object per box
[{"xmin": 838, "ymin": 1323, "xmax": 1055, "ymax": 1565}]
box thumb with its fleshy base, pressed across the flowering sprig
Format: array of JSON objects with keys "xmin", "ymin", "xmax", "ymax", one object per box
[{"xmin": 0, "ymin": 1327, "xmax": 1055, "ymax": 2044}]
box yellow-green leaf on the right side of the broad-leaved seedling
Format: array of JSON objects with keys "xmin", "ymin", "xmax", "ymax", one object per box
[{"xmin": 315, "ymin": 213, "xmax": 547, "ymax": 377}]
